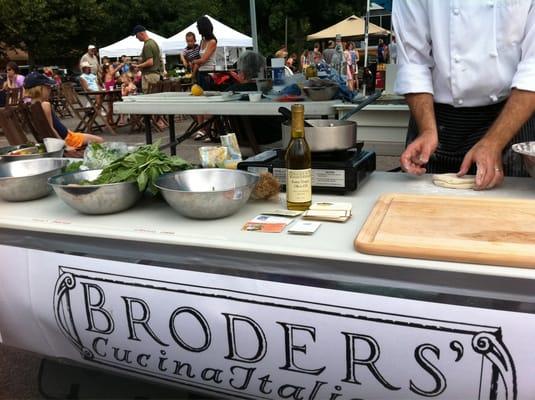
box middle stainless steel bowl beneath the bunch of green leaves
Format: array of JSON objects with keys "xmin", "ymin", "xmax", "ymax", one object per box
[{"xmin": 48, "ymin": 169, "xmax": 142, "ymax": 214}]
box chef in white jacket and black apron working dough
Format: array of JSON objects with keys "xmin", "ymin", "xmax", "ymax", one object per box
[{"xmin": 392, "ymin": 0, "xmax": 535, "ymax": 189}]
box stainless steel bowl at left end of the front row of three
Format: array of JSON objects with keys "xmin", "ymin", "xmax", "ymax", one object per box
[{"xmin": 0, "ymin": 158, "xmax": 69, "ymax": 201}]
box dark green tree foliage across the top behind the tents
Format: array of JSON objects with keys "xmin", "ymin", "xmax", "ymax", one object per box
[{"xmin": 0, "ymin": 0, "xmax": 366, "ymax": 66}]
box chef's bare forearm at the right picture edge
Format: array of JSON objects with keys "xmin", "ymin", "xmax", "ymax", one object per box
[{"xmin": 484, "ymin": 89, "xmax": 535, "ymax": 149}]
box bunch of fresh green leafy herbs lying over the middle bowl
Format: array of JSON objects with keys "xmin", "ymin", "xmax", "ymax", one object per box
[{"xmin": 89, "ymin": 143, "xmax": 192, "ymax": 195}]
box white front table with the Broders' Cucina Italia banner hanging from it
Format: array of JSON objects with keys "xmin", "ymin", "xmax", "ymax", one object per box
[{"xmin": 0, "ymin": 172, "xmax": 535, "ymax": 399}]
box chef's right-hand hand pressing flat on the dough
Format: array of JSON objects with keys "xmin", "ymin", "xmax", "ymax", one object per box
[{"xmin": 457, "ymin": 138, "xmax": 503, "ymax": 190}]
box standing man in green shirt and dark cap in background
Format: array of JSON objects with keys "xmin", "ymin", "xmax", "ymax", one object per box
[{"xmin": 133, "ymin": 25, "xmax": 162, "ymax": 93}]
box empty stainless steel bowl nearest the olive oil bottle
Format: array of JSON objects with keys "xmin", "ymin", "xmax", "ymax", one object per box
[{"xmin": 156, "ymin": 168, "xmax": 258, "ymax": 219}]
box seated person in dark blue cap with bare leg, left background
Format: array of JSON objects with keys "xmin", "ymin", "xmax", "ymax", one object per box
[{"xmin": 24, "ymin": 72, "xmax": 104, "ymax": 150}]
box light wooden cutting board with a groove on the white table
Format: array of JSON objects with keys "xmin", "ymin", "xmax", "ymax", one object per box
[{"xmin": 355, "ymin": 193, "xmax": 535, "ymax": 268}]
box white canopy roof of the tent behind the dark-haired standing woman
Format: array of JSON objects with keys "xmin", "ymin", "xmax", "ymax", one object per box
[{"xmin": 162, "ymin": 15, "xmax": 253, "ymax": 54}]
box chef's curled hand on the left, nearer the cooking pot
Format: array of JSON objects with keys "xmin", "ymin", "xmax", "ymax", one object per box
[{"xmin": 399, "ymin": 132, "xmax": 438, "ymax": 175}]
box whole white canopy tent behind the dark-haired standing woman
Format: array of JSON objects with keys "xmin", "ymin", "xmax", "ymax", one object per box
[{"xmin": 162, "ymin": 15, "xmax": 253, "ymax": 68}]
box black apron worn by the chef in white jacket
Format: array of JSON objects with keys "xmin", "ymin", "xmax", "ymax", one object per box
[{"xmin": 406, "ymin": 102, "xmax": 535, "ymax": 176}]
